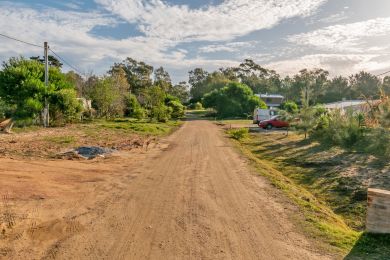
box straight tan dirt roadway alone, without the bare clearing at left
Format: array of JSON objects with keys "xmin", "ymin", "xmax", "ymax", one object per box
[{"xmin": 55, "ymin": 121, "xmax": 328, "ymax": 259}]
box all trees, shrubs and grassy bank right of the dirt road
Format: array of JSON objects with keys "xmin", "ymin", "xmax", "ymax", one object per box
[{"xmin": 190, "ymin": 60, "xmax": 390, "ymax": 259}]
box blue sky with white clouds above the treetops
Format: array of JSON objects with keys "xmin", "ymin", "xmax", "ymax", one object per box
[{"xmin": 0, "ymin": 0, "xmax": 390, "ymax": 82}]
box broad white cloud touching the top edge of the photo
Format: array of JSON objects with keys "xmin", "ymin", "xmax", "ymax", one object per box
[{"xmin": 95, "ymin": 0, "xmax": 327, "ymax": 41}]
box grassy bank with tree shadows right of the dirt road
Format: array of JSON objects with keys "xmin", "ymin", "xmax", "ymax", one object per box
[{"xmin": 230, "ymin": 132, "xmax": 390, "ymax": 259}]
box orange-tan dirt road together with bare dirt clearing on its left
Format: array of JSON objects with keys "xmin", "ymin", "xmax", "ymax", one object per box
[{"xmin": 0, "ymin": 121, "xmax": 327, "ymax": 259}]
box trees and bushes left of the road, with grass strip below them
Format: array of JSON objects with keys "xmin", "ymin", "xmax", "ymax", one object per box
[{"xmin": 0, "ymin": 56, "xmax": 187, "ymax": 146}]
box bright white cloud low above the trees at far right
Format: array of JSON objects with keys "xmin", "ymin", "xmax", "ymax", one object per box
[{"xmin": 278, "ymin": 17, "xmax": 390, "ymax": 75}]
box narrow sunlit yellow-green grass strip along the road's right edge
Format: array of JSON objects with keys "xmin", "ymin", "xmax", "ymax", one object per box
[{"xmin": 229, "ymin": 133, "xmax": 360, "ymax": 254}]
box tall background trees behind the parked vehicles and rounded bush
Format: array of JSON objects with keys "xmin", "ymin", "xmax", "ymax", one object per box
[{"xmin": 189, "ymin": 59, "xmax": 390, "ymax": 104}]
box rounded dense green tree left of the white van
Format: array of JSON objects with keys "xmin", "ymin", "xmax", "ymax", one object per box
[{"xmin": 202, "ymin": 82, "xmax": 266, "ymax": 118}]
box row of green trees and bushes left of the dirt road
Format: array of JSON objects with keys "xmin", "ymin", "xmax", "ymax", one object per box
[{"xmin": 0, "ymin": 56, "xmax": 189, "ymax": 130}]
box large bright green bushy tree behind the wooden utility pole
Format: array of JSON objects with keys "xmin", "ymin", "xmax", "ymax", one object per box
[{"xmin": 0, "ymin": 57, "xmax": 79, "ymax": 121}]
